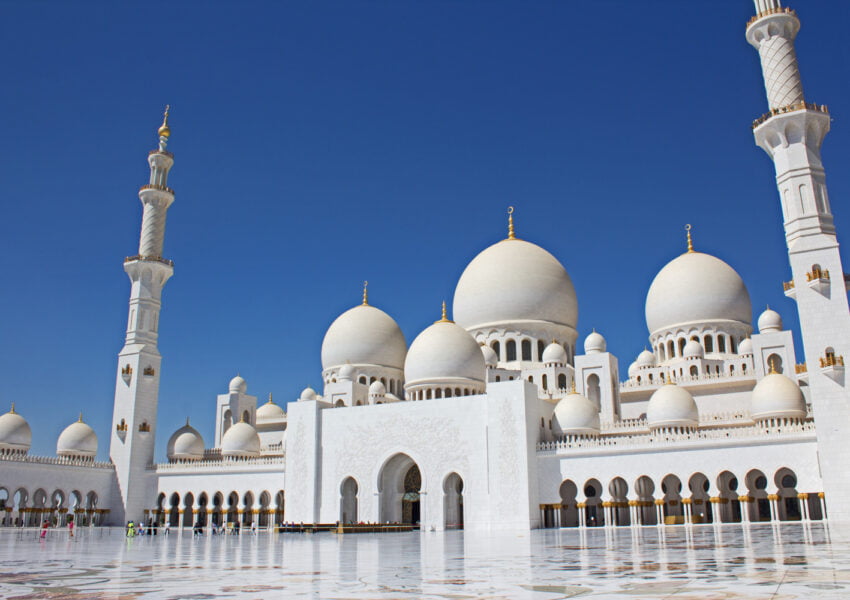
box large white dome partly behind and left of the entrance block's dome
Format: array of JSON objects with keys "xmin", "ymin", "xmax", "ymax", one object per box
[{"xmin": 322, "ymin": 304, "xmax": 407, "ymax": 369}]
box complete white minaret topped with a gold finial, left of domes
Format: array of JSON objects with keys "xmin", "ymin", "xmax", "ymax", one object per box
[{"xmin": 109, "ymin": 106, "xmax": 174, "ymax": 522}]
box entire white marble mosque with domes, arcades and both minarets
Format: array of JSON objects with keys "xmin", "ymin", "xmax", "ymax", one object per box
[{"xmin": 0, "ymin": 0, "xmax": 850, "ymax": 531}]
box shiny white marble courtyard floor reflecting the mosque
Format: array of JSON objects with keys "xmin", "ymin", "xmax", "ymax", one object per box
[{"xmin": 0, "ymin": 523, "xmax": 850, "ymax": 600}]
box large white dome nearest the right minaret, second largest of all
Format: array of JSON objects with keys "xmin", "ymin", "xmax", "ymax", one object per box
[{"xmin": 646, "ymin": 252, "xmax": 752, "ymax": 334}]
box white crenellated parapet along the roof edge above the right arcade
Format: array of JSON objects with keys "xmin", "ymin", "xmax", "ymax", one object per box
[{"xmin": 537, "ymin": 419, "xmax": 815, "ymax": 454}]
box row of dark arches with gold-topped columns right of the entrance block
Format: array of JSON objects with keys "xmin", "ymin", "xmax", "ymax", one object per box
[{"xmin": 540, "ymin": 467, "xmax": 827, "ymax": 527}]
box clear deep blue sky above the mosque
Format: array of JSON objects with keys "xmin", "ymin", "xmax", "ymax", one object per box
[{"xmin": 0, "ymin": 0, "xmax": 850, "ymax": 457}]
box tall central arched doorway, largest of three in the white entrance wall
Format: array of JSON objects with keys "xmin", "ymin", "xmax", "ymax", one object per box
[{"xmin": 378, "ymin": 454, "xmax": 422, "ymax": 525}]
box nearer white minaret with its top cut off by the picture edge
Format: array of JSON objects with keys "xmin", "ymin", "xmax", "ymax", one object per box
[{"xmin": 747, "ymin": 0, "xmax": 850, "ymax": 521}]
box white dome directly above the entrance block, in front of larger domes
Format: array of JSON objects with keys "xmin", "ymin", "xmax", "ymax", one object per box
[{"xmin": 404, "ymin": 321, "xmax": 486, "ymax": 388}]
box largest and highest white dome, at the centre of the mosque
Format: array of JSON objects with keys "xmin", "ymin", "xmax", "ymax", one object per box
[{"xmin": 453, "ymin": 240, "xmax": 578, "ymax": 329}]
